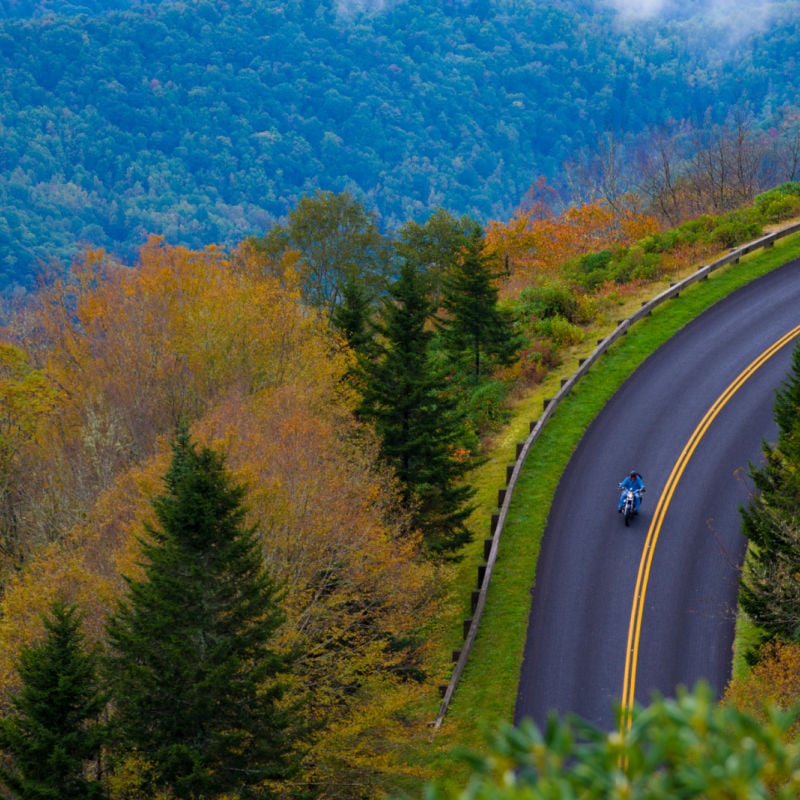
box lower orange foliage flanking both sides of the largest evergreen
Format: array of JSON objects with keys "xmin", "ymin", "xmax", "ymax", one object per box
[{"xmin": 0, "ymin": 385, "xmax": 436, "ymax": 797}]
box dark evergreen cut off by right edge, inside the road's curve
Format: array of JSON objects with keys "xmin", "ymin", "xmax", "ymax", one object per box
[{"xmin": 739, "ymin": 345, "xmax": 800, "ymax": 660}]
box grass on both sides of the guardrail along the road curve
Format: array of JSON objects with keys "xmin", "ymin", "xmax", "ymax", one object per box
[{"xmin": 430, "ymin": 223, "xmax": 800, "ymax": 780}]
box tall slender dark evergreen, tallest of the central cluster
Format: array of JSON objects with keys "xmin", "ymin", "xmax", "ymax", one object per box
[{"xmin": 359, "ymin": 263, "xmax": 474, "ymax": 554}]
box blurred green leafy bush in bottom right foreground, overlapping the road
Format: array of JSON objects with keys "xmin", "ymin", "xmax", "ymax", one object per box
[{"xmin": 425, "ymin": 684, "xmax": 800, "ymax": 800}]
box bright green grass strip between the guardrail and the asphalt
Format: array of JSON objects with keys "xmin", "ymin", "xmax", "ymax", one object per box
[{"xmin": 435, "ymin": 230, "xmax": 800, "ymax": 781}]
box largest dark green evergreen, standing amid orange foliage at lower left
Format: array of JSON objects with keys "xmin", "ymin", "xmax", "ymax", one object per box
[{"xmin": 108, "ymin": 431, "xmax": 297, "ymax": 798}]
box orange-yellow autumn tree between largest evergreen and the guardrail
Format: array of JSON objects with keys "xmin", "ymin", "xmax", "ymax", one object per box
[{"xmin": 197, "ymin": 384, "xmax": 436, "ymax": 798}]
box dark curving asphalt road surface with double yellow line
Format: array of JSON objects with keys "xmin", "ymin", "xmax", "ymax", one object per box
[{"xmin": 515, "ymin": 261, "xmax": 800, "ymax": 730}]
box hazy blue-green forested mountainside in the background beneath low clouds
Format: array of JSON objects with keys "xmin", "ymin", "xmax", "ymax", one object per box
[{"xmin": 0, "ymin": 0, "xmax": 798, "ymax": 289}]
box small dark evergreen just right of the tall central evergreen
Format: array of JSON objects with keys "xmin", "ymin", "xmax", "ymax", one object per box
[{"xmin": 439, "ymin": 224, "xmax": 521, "ymax": 383}]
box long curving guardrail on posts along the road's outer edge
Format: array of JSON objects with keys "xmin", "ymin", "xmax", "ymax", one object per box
[{"xmin": 433, "ymin": 223, "xmax": 800, "ymax": 730}]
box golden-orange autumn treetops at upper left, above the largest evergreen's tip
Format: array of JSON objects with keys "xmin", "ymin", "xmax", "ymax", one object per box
[{"xmin": 17, "ymin": 238, "xmax": 324, "ymax": 542}]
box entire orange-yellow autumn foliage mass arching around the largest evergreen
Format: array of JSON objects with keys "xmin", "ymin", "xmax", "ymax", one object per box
[{"xmin": 0, "ymin": 240, "xmax": 437, "ymax": 797}]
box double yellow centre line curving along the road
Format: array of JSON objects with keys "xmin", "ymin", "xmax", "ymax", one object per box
[{"xmin": 620, "ymin": 325, "xmax": 800, "ymax": 731}]
